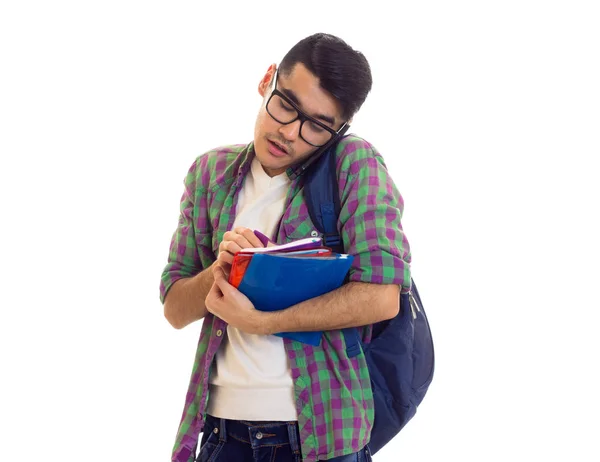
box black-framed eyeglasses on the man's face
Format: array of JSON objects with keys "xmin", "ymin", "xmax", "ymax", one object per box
[{"xmin": 266, "ymin": 72, "xmax": 348, "ymax": 147}]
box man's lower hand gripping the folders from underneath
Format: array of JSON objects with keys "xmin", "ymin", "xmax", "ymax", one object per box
[{"xmin": 205, "ymin": 266, "xmax": 269, "ymax": 335}]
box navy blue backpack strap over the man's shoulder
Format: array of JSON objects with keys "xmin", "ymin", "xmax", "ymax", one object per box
[{"xmin": 304, "ymin": 139, "xmax": 361, "ymax": 358}]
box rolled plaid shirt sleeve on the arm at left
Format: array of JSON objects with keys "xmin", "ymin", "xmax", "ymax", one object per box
[{"xmin": 160, "ymin": 162, "xmax": 209, "ymax": 303}]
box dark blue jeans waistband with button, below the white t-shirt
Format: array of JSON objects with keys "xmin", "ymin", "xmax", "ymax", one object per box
[{"xmin": 206, "ymin": 415, "xmax": 300, "ymax": 454}]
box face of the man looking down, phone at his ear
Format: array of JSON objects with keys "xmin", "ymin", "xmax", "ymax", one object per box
[{"xmin": 254, "ymin": 63, "xmax": 345, "ymax": 176}]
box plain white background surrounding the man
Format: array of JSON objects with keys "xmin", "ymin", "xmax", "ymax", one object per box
[{"xmin": 0, "ymin": 0, "xmax": 600, "ymax": 462}]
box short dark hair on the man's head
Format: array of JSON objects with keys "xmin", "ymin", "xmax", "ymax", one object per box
[{"xmin": 279, "ymin": 33, "xmax": 373, "ymax": 120}]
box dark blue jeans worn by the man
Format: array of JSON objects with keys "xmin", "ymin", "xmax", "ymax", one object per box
[{"xmin": 196, "ymin": 415, "xmax": 371, "ymax": 462}]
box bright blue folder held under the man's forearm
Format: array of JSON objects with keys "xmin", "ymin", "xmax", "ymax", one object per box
[{"xmin": 238, "ymin": 253, "xmax": 354, "ymax": 346}]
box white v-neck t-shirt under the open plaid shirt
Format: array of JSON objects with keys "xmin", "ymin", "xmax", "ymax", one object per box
[{"xmin": 207, "ymin": 158, "xmax": 298, "ymax": 421}]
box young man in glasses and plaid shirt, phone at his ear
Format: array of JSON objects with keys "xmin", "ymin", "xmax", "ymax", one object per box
[{"xmin": 161, "ymin": 34, "xmax": 410, "ymax": 462}]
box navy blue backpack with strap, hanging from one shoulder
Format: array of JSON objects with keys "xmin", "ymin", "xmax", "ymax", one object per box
[{"xmin": 304, "ymin": 140, "xmax": 434, "ymax": 454}]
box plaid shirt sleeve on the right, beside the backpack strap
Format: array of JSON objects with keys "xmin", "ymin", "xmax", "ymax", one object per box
[{"xmin": 339, "ymin": 138, "xmax": 411, "ymax": 292}]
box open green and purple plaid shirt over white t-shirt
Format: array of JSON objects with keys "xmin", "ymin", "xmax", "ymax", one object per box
[{"xmin": 160, "ymin": 135, "xmax": 410, "ymax": 462}]
